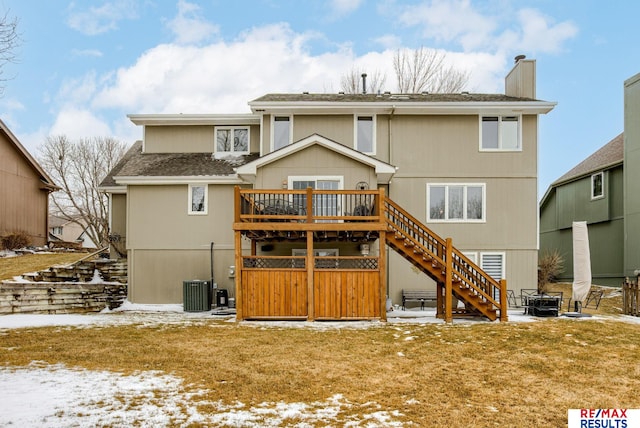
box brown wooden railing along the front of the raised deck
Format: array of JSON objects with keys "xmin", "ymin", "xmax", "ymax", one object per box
[{"xmin": 236, "ymin": 188, "xmax": 381, "ymax": 223}]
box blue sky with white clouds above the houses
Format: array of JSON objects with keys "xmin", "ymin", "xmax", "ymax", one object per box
[{"xmin": 0, "ymin": 0, "xmax": 640, "ymax": 196}]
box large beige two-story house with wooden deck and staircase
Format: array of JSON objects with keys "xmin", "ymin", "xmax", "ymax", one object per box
[{"xmin": 102, "ymin": 57, "xmax": 555, "ymax": 320}]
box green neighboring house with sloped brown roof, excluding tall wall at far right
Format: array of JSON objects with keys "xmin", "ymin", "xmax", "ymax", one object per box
[{"xmin": 540, "ymin": 134, "xmax": 624, "ymax": 285}]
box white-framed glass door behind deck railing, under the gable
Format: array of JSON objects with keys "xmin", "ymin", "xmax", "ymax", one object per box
[{"xmin": 289, "ymin": 176, "xmax": 343, "ymax": 221}]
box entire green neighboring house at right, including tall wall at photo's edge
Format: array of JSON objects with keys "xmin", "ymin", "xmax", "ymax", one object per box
[{"xmin": 539, "ymin": 74, "xmax": 640, "ymax": 286}]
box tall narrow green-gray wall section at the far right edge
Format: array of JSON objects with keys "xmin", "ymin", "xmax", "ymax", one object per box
[{"xmin": 624, "ymin": 74, "xmax": 640, "ymax": 277}]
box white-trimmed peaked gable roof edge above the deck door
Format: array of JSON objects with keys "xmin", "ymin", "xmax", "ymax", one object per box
[{"xmin": 235, "ymin": 134, "xmax": 396, "ymax": 183}]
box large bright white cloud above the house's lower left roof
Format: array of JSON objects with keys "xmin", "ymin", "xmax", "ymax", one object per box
[{"xmin": 89, "ymin": 24, "xmax": 362, "ymax": 113}]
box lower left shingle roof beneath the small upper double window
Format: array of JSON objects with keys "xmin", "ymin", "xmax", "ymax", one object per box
[{"xmin": 101, "ymin": 141, "xmax": 259, "ymax": 187}]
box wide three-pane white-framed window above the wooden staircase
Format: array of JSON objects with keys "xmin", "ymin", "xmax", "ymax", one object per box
[{"xmin": 427, "ymin": 184, "xmax": 485, "ymax": 222}]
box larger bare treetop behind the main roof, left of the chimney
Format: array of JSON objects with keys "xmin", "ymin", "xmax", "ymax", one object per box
[{"xmin": 393, "ymin": 47, "xmax": 469, "ymax": 94}]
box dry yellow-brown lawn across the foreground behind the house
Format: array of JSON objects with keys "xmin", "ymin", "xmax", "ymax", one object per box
[{"xmin": 0, "ymin": 288, "xmax": 640, "ymax": 427}]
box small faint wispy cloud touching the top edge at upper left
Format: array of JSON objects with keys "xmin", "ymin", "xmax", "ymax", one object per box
[{"xmin": 67, "ymin": 0, "xmax": 138, "ymax": 36}]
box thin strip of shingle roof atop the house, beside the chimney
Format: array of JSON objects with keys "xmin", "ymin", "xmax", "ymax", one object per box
[{"xmin": 249, "ymin": 92, "xmax": 537, "ymax": 104}]
